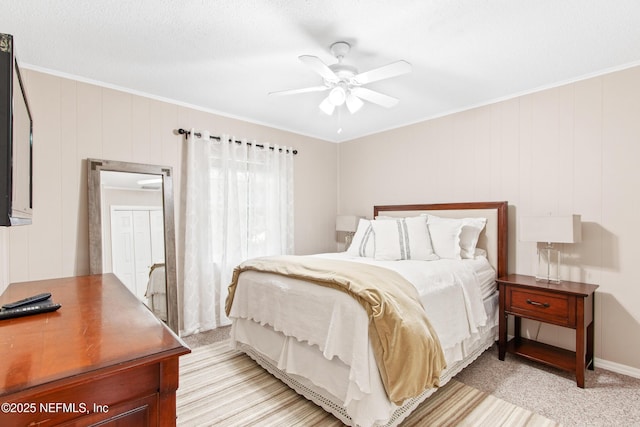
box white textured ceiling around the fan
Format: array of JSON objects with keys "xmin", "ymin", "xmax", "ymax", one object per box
[{"xmin": 0, "ymin": 0, "xmax": 640, "ymax": 142}]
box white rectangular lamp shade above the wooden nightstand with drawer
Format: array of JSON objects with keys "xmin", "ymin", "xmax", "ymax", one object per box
[{"xmin": 520, "ymin": 215, "xmax": 582, "ymax": 243}]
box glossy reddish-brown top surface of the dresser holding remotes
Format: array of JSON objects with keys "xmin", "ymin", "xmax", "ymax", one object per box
[{"xmin": 0, "ymin": 274, "xmax": 190, "ymax": 396}]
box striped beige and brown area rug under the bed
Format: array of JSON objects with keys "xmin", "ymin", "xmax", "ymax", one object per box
[{"xmin": 177, "ymin": 341, "xmax": 558, "ymax": 427}]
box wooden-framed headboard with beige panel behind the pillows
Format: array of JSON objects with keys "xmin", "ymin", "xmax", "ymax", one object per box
[{"xmin": 373, "ymin": 202, "xmax": 508, "ymax": 277}]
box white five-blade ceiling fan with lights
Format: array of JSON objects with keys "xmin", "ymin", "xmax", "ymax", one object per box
[{"xmin": 269, "ymin": 41, "xmax": 411, "ymax": 115}]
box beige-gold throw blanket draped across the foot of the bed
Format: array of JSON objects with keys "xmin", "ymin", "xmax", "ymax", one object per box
[{"xmin": 225, "ymin": 256, "xmax": 446, "ymax": 405}]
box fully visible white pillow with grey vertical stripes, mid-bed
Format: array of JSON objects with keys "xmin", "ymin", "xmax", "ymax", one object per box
[{"xmin": 371, "ymin": 217, "xmax": 438, "ymax": 261}]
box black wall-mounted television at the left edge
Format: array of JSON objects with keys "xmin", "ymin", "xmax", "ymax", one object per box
[{"xmin": 0, "ymin": 33, "xmax": 33, "ymax": 226}]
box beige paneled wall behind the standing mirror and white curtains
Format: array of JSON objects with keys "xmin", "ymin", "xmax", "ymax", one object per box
[{"xmin": 0, "ymin": 70, "xmax": 337, "ymax": 292}]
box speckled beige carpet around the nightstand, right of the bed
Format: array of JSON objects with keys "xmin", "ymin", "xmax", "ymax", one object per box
[{"xmin": 455, "ymin": 346, "xmax": 640, "ymax": 427}]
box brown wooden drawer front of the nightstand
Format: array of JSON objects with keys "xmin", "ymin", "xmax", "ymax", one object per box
[{"xmin": 505, "ymin": 287, "xmax": 576, "ymax": 328}]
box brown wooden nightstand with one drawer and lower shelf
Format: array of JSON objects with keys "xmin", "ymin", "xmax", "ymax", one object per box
[{"xmin": 497, "ymin": 274, "xmax": 598, "ymax": 388}]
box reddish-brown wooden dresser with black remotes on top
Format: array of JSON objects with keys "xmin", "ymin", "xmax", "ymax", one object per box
[{"xmin": 0, "ymin": 274, "xmax": 190, "ymax": 427}]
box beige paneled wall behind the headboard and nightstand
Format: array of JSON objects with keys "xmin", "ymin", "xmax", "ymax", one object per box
[{"xmin": 338, "ymin": 67, "xmax": 640, "ymax": 375}]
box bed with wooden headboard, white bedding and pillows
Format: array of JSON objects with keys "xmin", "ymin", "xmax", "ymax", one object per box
[{"xmin": 222, "ymin": 202, "xmax": 507, "ymax": 426}]
